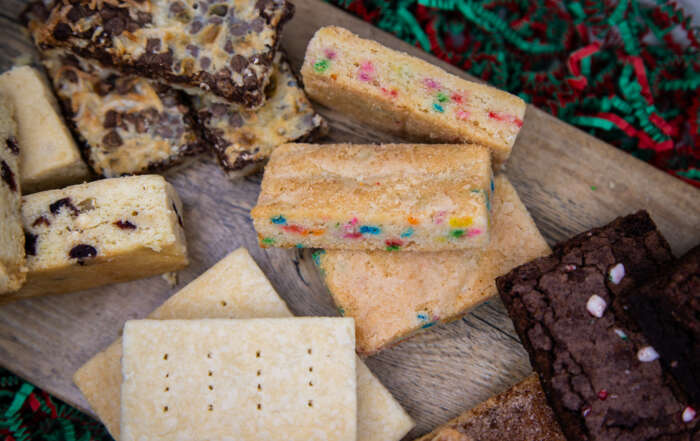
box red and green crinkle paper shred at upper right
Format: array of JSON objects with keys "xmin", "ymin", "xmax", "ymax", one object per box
[{"xmin": 328, "ymin": 0, "xmax": 700, "ymax": 187}]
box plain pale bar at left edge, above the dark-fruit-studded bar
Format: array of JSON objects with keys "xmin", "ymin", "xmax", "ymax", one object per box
[{"xmin": 0, "ymin": 66, "xmax": 90, "ymax": 194}]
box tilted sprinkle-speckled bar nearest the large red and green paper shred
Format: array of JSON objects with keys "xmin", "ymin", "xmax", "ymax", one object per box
[{"xmin": 301, "ymin": 26, "xmax": 525, "ymax": 165}]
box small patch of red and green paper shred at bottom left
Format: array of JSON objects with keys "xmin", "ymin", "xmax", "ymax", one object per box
[{"xmin": 0, "ymin": 368, "xmax": 112, "ymax": 441}]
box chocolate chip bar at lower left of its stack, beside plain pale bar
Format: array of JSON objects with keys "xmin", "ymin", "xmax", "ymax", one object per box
[{"xmin": 42, "ymin": 49, "xmax": 202, "ymax": 177}]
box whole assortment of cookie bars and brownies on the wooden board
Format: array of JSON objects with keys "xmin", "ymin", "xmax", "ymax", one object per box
[{"xmin": 0, "ymin": 0, "xmax": 700, "ymax": 441}]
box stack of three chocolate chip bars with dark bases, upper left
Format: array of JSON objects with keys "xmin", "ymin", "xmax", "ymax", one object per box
[{"xmin": 24, "ymin": 0, "xmax": 326, "ymax": 178}]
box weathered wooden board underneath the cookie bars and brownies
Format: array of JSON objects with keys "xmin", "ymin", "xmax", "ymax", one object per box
[{"xmin": 0, "ymin": 0, "xmax": 700, "ymax": 439}]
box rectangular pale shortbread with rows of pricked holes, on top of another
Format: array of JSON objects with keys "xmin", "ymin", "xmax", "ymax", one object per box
[{"xmin": 121, "ymin": 317, "xmax": 357, "ymax": 441}]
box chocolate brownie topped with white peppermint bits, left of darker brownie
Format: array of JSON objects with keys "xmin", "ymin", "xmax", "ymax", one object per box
[{"xmin": 496, "ymin": 211, "xmax": 698, "ymax": 441}]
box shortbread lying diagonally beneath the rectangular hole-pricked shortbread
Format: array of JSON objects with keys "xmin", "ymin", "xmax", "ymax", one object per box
[{"xmin": 73, "ymin": 248, "xmax": 414, "ymax": 441}]
